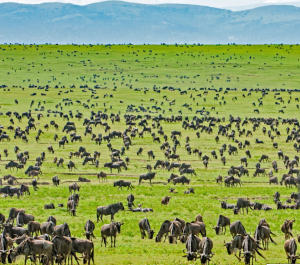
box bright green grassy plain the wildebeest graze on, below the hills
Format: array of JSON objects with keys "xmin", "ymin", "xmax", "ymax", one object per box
[{"xmin": 0, "ymin": 45, "xmax": 300, "ymax": 265}]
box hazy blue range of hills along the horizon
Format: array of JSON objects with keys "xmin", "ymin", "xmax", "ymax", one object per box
[{"xmin": 0, "ymin": 1, "xmax": 300, "ymax": 44}]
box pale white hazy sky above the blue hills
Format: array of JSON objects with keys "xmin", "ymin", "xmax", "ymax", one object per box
[{"xmin": 0, "ymin": 0, "xmax": 300, "ymax": 7}]
